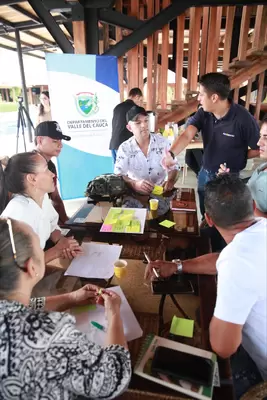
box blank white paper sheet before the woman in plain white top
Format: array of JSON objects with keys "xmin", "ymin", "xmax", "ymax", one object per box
[{"xmin": 65, "ymin": 242, "xmax": 122, "ymax": 279}]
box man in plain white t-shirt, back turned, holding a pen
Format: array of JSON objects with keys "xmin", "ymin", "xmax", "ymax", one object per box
[{"xmin": 146, "ymin": 174, "xmax": 267, "ymax": 397}]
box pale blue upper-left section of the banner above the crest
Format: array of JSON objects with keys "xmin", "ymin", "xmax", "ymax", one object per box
[{"xmin": 45, "ymin": 54, "xmax": 96, "ymax": 84}]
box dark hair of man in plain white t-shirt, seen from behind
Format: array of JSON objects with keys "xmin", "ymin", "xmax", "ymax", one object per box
[{"xmin": 205, "ymin": 174, "xmax": 253, "ymax": 228}]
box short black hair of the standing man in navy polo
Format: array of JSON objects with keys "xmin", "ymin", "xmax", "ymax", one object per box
[{"xmin": 199, "ymin": 72, "xmax": 231, "ymax": 100}]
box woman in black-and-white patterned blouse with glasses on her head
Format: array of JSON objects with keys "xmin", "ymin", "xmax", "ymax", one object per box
[{"xmin": 0, "ymin": 219, "xmax": 131, "ymax": 400}]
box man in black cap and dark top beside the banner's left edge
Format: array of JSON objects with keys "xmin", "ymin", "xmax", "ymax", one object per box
[{"xmin": 35, "ymin": 121, "xmax": 71, "ymax": 223}]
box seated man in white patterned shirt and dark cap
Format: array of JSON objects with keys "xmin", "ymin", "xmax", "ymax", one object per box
[{"xmin": 114, "ymin": 106, "xmax": 178, "ymax": 215}]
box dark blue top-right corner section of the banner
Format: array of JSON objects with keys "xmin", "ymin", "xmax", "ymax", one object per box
[{"xmin": 95, "ymin": 56, "xmax": 119, "ymax": 92}]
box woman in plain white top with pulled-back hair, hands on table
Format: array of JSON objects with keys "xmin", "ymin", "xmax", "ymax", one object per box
[{"xmin": 0, "ymin": 152, "xmax": 81, "ymax": 263}]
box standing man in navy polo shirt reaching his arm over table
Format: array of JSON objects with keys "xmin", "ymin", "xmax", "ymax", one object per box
[{"xmin": 163, "ymin": 72, "xmax": 259, "ymax": 215}]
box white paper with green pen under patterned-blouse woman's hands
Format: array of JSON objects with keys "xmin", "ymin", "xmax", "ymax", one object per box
[{"xmin": 74, "ymin": 286, "xmax": 143, "ymax": 346}]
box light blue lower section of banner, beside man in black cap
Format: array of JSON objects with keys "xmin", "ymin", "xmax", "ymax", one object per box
[{"xmin": 58, "ymin": 143, "xmax": 113, "ymax": 200}]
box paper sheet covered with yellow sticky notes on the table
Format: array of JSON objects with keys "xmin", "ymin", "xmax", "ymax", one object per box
[{"xmin": 100, "ymin": 207, "xmax": 147, "ymax": 233}]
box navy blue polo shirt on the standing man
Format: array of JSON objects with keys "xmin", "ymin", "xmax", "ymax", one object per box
[{"xmin": 190, "ymin": 103, "xmax": 260, "ymax": 172}]
